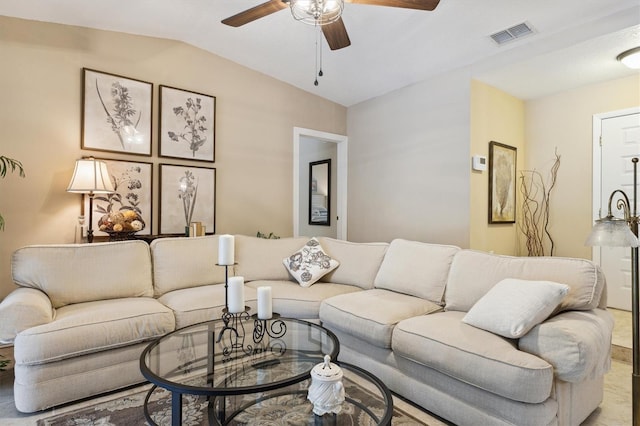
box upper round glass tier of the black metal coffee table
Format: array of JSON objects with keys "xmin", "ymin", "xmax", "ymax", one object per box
[{"xmin": 140, "ymin": 312, "xmax": 340, "ymax": 425}]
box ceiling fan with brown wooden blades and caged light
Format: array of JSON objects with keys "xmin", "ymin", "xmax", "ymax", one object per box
[{"xmin": 222, "ymin": 0, "xmax": 440, "ymax": 50}]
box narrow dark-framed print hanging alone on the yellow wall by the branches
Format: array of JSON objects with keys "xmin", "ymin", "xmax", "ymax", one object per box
[{"xmin": 489, "ymin": 141, "xmax": 517, "ymax": 223}]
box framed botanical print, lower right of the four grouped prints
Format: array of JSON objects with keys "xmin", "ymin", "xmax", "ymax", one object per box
[{"xmin": 159, "ymin": 164, "xmax": 216, "ymax": 235}]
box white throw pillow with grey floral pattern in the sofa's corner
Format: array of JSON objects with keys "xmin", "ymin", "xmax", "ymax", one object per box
[{"xmin": 282, "ymin": 238, "xmax": 340, "ymax": 287}]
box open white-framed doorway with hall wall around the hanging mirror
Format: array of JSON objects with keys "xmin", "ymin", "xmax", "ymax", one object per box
[{"xmin": 293, "ymin": 127, "xmax": 348, "ymax": 240}]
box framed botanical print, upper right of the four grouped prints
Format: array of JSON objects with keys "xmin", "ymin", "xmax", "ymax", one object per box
[{"xmin": 158, "ymin": 85, "xmax": 216, "ymax": 162}]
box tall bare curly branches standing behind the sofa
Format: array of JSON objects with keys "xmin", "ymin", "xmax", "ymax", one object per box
[{"xmin": 518, "ymin": 148, "xmax": 560, "ymax": 256}]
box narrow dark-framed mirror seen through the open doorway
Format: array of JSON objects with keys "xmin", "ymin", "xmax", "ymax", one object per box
[{"xmin": 309, "ymin": 159, "xmax": 331, "ymax": 226}]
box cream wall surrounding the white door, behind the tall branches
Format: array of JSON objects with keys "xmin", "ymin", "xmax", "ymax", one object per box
[{"xmin": 525, "ymin": 76, "xmax": 640, "ymax": 259}]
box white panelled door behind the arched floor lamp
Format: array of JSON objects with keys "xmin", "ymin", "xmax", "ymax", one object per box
[{"xmin": 593, "ymin": 107, "xmax": 640, "ymax": 311}]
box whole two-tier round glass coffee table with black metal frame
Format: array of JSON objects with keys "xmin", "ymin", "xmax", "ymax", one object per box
[{"xmin": 140, "ymin": 312, "xmax": 393, "ymax": 425}]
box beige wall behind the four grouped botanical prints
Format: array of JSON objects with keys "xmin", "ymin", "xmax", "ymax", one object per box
[{"xmin": 0, "ymin": 17, "xmax": 346, "ymax": 299}]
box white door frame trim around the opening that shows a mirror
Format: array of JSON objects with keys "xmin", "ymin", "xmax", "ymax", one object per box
[{"xmin": 293, "ymin": 127, "xmax": 348, "ymax": 240}]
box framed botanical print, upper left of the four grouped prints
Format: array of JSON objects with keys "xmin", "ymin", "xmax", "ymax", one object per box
[{"xmin": 81, "ymin": 68, "xmax": 153, "ymax": 156}]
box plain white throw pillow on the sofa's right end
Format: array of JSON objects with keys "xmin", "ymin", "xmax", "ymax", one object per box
[{"xmin": 462, "ymin": 278, "xmax": 569, "ymax": 339}]
